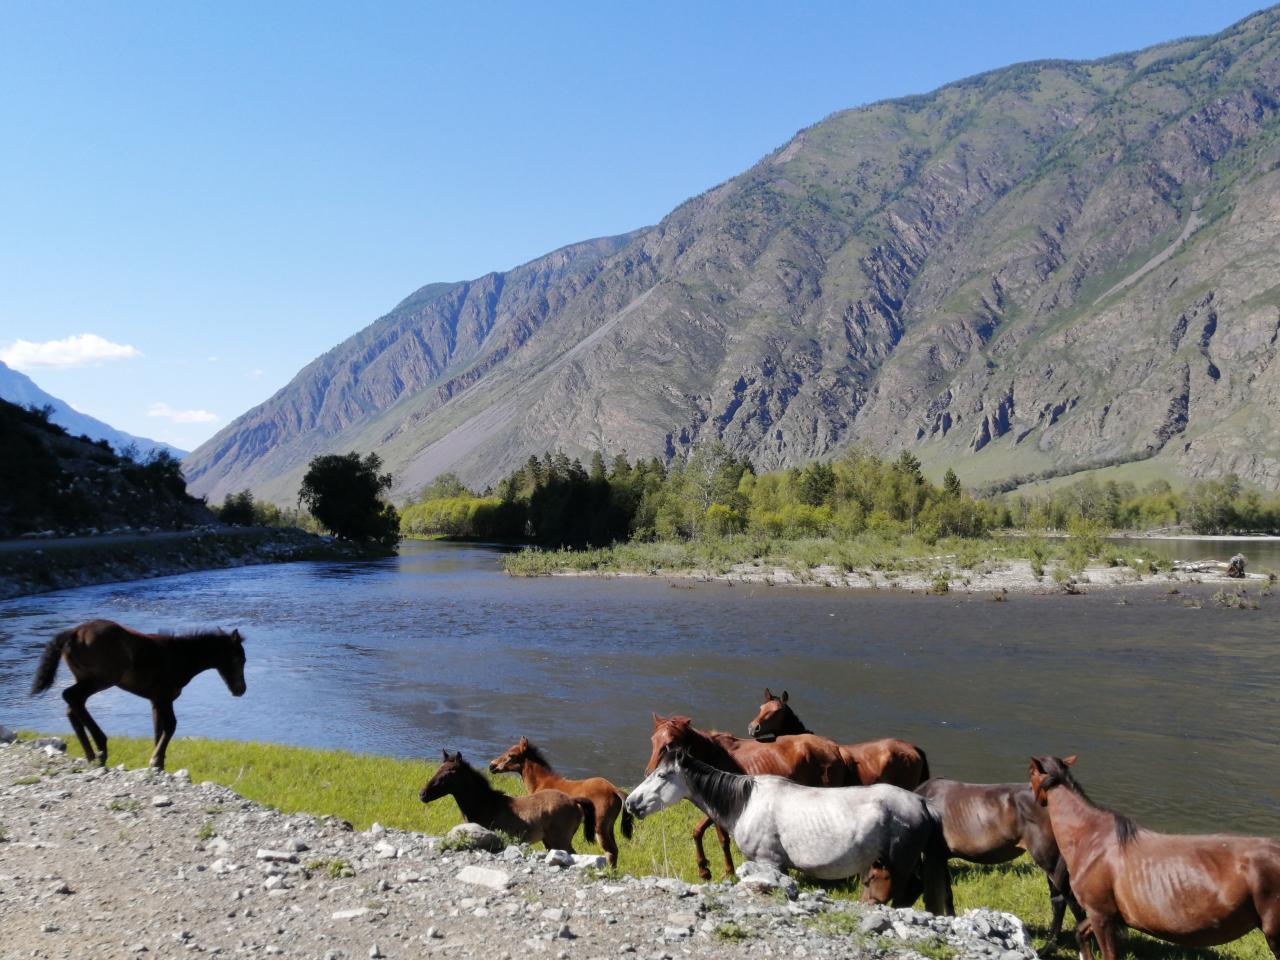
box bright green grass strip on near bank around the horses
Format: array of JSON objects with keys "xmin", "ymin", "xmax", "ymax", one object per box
[{"xmin": 20, "ymin": 737, "xmax": 1270, "ymax": 960}]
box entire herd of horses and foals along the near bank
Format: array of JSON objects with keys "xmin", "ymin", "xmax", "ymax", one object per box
[{"xmin": 20, "ymin": 620, "xmax": 1280, "ymax": 960}]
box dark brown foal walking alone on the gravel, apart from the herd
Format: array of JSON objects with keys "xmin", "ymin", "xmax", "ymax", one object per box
[{"xmin": 31, "ymin": 620, "xmax": 244, "ymax": 771}]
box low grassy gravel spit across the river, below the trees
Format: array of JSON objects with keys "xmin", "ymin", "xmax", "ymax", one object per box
[{"xmin": 503, "ymin": 536, "xmax": 1274, "ymax": 595}]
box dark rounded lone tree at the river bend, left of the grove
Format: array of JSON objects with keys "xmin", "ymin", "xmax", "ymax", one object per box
[{"xmin": 298, "ymin": 451, "xmax": 399, "ymax": 547}]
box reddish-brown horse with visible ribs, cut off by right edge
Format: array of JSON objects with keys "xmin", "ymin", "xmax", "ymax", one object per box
[{"xmin": 1029, "ymin": 756, "xmax": 1280, "ymax": 960}]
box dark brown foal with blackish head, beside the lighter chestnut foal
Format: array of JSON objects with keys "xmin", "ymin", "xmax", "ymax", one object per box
[{"xmin": 419, "ymin": 750, "xmax": 595, "ymax": 854}]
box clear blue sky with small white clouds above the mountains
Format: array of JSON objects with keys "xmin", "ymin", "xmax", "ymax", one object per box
[{"xmin": 0, "ymin": 0, "xmax": 1257, "ymax": 448}]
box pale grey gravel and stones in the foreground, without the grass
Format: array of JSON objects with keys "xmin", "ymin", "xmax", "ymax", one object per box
[{"xmin": 0, "ymin": 742, "xmax": 1034, "ymax": 960}]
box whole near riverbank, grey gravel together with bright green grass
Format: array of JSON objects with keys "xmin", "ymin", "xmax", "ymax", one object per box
[{"xmin": 0, "ymin": 739, "xmax": 1267, "ymax": 960}]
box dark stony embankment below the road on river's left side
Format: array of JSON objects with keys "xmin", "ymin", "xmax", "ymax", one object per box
[{"xmin": 0, "ymin": 527, "xmax": 388, "ymax": 600}]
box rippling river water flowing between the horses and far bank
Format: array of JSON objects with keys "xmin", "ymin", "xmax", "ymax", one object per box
[{"xmin": 0, "ymin": 543, "xmax": 1280, "ymax": 835}]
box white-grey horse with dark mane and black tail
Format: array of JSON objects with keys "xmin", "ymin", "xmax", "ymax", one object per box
[{"xmin": 626, "ymin": 749, "xmax": 955, "ymax": 914}]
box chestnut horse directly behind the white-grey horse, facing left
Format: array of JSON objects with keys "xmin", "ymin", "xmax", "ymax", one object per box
[{"xmin": 646, "ymin": 713, "xmax": 915, "ymax": 879}]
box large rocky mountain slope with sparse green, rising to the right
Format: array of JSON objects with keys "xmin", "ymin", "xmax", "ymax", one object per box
[{"xmin": 184, "ymin": 8, "xmax": 1280, "ymax": 500}]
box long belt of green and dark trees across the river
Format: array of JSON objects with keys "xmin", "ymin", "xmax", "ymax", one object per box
[{"xmin": 402, "ymin": 444, "xmax": 993, "ymax": 547}]
